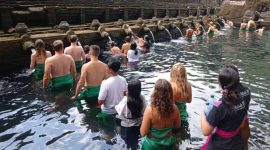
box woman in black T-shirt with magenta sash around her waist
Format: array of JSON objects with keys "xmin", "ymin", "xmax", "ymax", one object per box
[{"xmin": 201, "ymin": 67, "xmax": 248, "ymax": 150}]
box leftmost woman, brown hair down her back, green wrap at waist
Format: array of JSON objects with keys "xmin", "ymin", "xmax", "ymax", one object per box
[{"xmin": 30, "ymin": 39, "xmax": 52, "ymax": 80}]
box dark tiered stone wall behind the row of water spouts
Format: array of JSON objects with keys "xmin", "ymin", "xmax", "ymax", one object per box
[{"xmin": 0, "ymin": 0, "xmax": 219, "ymax": 32}]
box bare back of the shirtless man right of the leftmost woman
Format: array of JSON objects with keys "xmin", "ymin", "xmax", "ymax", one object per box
[{"xmin": 46, "ymin": 54, "xmax": 75, "ymax": 78}]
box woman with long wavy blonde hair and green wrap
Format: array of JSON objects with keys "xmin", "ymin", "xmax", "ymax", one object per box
[{"xmin": 171, "ymin": 63, "xmax": 192, "ymax": 122}]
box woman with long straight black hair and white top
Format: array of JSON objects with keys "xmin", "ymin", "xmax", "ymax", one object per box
[{"xmin": 115, "ymin": 79, "xmax": 146, "ymax": 149}]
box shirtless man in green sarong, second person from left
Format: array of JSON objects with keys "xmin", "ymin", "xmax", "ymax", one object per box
[{"xmin": 43, "ymin": 40, "xmax": 76, "ymax": 90}]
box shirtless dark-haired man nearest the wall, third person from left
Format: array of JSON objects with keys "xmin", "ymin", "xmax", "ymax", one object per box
[{"xmin": 64, "ymin": 35, "xmax": 85, "ymax": 72}]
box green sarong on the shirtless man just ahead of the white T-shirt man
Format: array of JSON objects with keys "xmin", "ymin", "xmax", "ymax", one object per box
[{"xmin": 77, "ymin": 85, "xmax": 100, "ymax": 101}]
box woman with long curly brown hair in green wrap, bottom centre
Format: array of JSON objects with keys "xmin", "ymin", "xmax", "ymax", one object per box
[{"xmin": 140, "ymin": 79, "xmax": 180, "ymax": 150}]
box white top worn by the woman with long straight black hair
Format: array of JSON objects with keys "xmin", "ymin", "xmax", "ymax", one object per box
[{"xmin": 115, "ymin": 95, "xmax": 147, "ymax": 127}]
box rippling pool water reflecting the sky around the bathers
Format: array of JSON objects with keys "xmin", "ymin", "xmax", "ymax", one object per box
[{"xmin": 0, "ymin": 29, "xmax": 270, "ymax": 150}]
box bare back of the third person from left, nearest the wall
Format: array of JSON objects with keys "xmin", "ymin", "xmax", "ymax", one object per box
[{"xmin": 65, "ymin": 45, "xmax": 85, "ymax": 61}]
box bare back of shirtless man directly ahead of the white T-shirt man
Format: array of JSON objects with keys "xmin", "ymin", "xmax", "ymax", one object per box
[{"xmin": 81, "ymin": 61, "xmax": 107, "ymax": 86}]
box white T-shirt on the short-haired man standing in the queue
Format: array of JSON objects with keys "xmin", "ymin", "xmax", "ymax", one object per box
[{"xmin": 98, "ymin": 75, "xmax": 127, "ymax": 114}]
